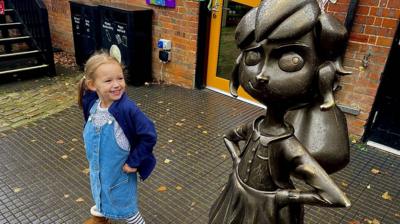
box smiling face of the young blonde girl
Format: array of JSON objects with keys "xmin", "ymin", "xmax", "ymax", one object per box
[{"xmin": 88, "ymin": 63, "xmax": 126, "ymax": 107}]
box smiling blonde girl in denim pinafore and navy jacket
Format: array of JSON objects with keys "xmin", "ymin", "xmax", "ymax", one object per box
[{"xmin": 78, "ymin": 53, "xmax": 157, "ymax": 224}]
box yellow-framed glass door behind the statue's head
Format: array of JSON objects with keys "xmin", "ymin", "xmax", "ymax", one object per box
[{"xmin": 207, "ymin": 0, "xmax": 260, "ymax": 99}]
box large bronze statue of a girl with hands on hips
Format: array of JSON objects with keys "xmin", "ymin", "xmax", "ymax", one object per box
[{"xmin": 209, "ymin": 0, "xmax": 350, "ymax": 224}]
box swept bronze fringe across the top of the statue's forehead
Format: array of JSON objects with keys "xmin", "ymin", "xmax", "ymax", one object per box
[{"xmin": 235, "ymin": 0, "xmax": 321, "ymax": 48}]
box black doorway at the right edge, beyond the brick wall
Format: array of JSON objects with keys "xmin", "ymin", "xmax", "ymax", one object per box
[{"xmin": 365, "ymin": 23, "xmax": 400, "ymax": 150}]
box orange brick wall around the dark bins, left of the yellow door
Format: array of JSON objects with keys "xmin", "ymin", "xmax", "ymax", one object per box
[{"xmin": 44, "ymin": 0, "xmax": 199, "ymax": 88}]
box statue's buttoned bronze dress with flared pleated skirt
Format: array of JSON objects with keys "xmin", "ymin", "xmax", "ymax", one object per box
[{"xmin": 209, "ymin": 117, "xmax": 303, "ymax": 224}]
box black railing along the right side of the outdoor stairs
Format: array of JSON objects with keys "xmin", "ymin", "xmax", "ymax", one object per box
[{"xmin": 6, "ymin": 0, "xmax": 55, "ymax": 75}]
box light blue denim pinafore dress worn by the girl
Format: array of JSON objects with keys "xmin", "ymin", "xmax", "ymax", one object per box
[{"xmin": 83, "ymin": 101, "xmax": 138, "ymax": 219}]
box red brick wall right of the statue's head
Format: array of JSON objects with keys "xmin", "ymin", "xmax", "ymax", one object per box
[{"xmin": 326, "ymin": 0, "xmax": 400, "ymax": 136}]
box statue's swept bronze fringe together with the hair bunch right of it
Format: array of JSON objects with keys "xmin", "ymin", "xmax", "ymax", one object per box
[{"xmin": 235, "ymin": 0, "xmax": 347, "ymax": 58}]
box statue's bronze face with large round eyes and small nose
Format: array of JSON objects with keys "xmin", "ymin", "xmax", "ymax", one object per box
[{"xmin": 239, "ymin": 32, "xmax": 317, "ymax": 107}]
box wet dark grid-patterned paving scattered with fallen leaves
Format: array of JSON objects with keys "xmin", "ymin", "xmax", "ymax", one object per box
[{"xmin": 0, "ymin": 76, "xmax": 400, "ymax": 224}]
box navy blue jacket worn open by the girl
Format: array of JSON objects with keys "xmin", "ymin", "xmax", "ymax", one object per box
[{"xmin": 82, "ymin": 91, "xmax": 157, "ymax": 180}]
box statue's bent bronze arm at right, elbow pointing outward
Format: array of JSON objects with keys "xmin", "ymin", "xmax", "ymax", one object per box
[{"xmin": 277, "ymin": 139, "xmax": 350, "ymax": 207}]
